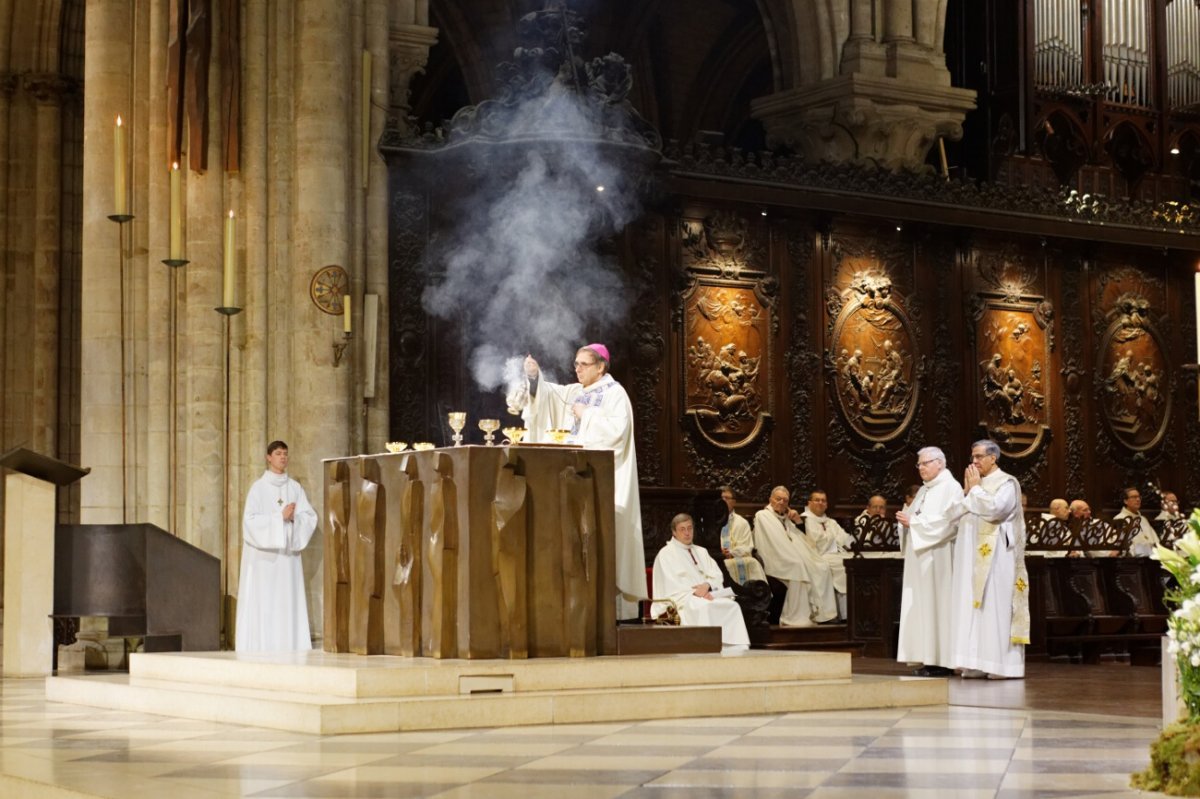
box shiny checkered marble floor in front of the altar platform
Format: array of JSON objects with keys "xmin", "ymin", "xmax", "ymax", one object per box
[{"xmin": 0, "ymin": 659, "xmax": 1159, "ymax": 799}]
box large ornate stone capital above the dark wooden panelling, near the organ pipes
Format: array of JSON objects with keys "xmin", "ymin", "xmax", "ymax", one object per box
[{"xmin": 751, "ymin": 73, "xmax": 976, "ymax": 172}]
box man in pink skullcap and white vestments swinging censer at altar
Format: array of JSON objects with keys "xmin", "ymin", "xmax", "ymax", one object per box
[{"xmin": 510, "ymin": 344, "xmax": 648, "ymax": 619}]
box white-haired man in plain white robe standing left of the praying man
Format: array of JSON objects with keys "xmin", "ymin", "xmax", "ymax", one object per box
[{"xmin": 896, "ymin": 446, "xmax": 964, "ymax": 677}]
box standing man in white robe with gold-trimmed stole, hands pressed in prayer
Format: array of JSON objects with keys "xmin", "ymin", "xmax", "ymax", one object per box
[{"xmin": 953, "ymin": 439, "xmax": 1030, "ymax": 678}]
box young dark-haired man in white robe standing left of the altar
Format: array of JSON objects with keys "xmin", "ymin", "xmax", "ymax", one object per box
[{"xmin": 235, "ymin": 441, "xmax": 317, "ymax": 651}]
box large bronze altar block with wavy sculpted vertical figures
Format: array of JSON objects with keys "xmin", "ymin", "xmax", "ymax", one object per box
[{"xmin": 324, "ymin": 446, "xmax": 617, "ymax": 659}]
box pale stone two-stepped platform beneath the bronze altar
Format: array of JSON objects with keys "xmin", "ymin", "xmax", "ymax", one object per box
[{"xmin": 46, "ymin": 651, "xmax": 948, "ymax": 735}]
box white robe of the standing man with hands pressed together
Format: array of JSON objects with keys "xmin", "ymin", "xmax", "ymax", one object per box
[{"xmin": 950, "ymin": 468, "xmax": 1025, "ymax": 677}]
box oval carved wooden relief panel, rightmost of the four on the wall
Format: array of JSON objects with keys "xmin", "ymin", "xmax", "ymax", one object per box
[{"xmin": 1096, "ymin": 270, "xmax": 1171, "ymax": 452}]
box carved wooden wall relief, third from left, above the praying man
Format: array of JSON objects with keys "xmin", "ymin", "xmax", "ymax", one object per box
[{"xmin": 972, "ymin": 247, "xmax": 1054, "ymax": 458}]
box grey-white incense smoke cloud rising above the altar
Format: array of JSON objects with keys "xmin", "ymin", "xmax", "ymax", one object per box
[{"xmin": 422, "ymin": 85, "xmax": 640, "ymax": 391}]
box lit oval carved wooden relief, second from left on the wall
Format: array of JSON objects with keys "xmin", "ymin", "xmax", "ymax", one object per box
[{"xmin": 826, "ymin": 244, "xmax": 920, "ymax": 444}]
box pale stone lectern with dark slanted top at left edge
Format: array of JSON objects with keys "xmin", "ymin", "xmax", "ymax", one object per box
[{"xmin": 0, "ymin": 447, "xmax": 90, "ymax": 677}]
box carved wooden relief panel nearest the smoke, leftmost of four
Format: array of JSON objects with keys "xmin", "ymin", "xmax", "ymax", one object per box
[{"xmin": 679, "ymin": 212, "xmax": 774, "ymax": 450}]
